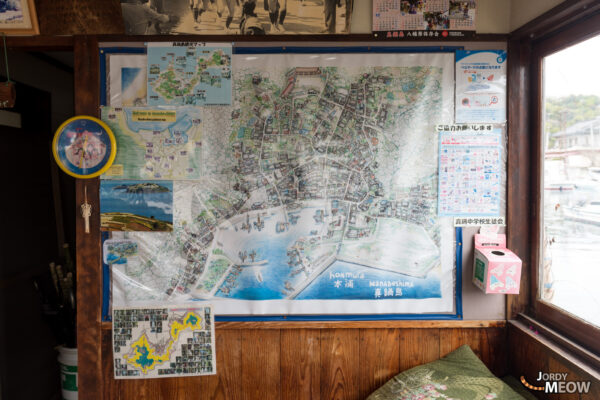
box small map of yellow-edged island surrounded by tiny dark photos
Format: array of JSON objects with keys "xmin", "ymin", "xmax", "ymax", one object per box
[{"xmin": 113, "ymin": 305, "xmax": 216, "ymax": 379}]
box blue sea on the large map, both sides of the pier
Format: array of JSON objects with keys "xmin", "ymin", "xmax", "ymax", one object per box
[{"xmin": 215, "ymin": 208, "xmax": 441, "ymax": 300}]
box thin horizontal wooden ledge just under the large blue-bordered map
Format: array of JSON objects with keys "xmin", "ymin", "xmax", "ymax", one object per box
[{"xmin": 102, "ymin": 320, "xmax": 506, "ymax": 330}]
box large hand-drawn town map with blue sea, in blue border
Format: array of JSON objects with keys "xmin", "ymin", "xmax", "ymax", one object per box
[{"xmin": 107, "ymin": 54, "xmax": 454, "ymax": 314}]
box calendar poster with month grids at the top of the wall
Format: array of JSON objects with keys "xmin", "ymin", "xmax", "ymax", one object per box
[{"xmin": 373, "ymin": 0, "xmax": 477, "ymax": 40}]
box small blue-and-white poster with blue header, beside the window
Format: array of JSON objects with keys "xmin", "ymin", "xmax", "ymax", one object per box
[{"xmin": 456, "ymin": 50, "xmax": 506, "ymax": 124}]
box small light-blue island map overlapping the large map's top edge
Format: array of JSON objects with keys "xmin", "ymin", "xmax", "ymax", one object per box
[{"xmin": 148, "ymin": 42, "xmax": 232, "ymax": 106}]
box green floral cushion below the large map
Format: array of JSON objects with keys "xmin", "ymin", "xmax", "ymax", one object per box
[{"xmin": 367, "ymin": 345, "xmax": 523, "ymax": 400}]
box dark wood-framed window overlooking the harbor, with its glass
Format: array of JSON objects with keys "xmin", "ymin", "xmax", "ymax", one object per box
[{"xmin": 532, "ymin": 13, "xmax": 600, "ymax": 354}]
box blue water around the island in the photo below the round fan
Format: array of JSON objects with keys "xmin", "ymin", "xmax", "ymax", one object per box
[{"xmin": 100, "ymin": 180, "xmax": 173, "ymax": 222}]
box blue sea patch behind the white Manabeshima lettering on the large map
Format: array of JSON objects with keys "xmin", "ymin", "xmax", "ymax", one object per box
[{"xmin": 296, "ymin": 261, "xmax": 442, "ymax": 300}]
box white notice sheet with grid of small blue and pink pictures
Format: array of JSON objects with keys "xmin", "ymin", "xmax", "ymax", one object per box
[{"xmin": 437, "ymin": 124, "xmax": 503, "ymax": 217}]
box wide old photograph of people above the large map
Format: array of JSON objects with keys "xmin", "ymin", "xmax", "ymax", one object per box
[{"xmin": 121, "ymin": 0, "xmax": 354, "ymax": 35}]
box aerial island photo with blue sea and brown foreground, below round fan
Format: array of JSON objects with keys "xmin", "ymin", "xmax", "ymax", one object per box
[{"xmin": 100, "ymin": 180, "xmax": 173, "ymax": 231}]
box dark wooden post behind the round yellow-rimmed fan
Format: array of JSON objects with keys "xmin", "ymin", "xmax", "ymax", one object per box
[{"xmin": 73, "ymin": 36, "xmax": 103, "ymax": 400}]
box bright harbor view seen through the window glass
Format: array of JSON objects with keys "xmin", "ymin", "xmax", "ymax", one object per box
[{"xmin": 539, "ymin": 36, "xmax": 600, "ymax": 326}]
